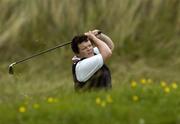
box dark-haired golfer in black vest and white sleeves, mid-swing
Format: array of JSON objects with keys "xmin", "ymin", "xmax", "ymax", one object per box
[{"xmin": 71, "ymin": 30, "xmax": 114, "ymax": 91}]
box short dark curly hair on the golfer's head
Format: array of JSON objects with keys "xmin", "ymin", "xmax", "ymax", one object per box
[{"xmin": 71, "ymin": 34, "xmax": 88, "ymax": 53}]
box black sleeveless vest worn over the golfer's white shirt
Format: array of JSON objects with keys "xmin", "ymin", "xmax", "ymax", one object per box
[{"xmin": 72, "ymin": 59, "xmax": 112, "ymax": 91}]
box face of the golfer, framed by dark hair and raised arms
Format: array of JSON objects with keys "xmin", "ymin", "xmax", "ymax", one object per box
[{"xmin": 78, "ymin": 40, "xmax": 94, "ymax": 58}]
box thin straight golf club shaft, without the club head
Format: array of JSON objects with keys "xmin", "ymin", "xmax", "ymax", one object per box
[{"xmin": 13, "ymin": 42, "xmax": 71, "ymax": 65}]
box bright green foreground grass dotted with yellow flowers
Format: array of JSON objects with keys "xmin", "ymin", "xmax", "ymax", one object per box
[{"xmin": 0, "ymin": 74, "xmax": 180, "ymax": 124}]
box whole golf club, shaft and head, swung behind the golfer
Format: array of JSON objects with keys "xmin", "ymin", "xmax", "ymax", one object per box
[{"xmin": 9, "ymin": 42, "xmax": 71, "ymax": 74}]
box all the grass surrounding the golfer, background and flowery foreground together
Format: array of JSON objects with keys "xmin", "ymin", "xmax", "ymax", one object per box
[{"xmin": 0, "ymin": 0, "xmax": 180, "ymax": 124}]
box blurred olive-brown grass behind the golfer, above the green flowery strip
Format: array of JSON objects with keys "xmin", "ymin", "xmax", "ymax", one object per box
[{"xmin": 0, "ymin": 0, "xmax": 180, "ymax": 123}]
